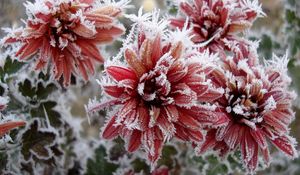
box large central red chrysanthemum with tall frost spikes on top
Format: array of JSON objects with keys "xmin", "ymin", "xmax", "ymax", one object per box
[{"xmin": 88, "ymin": 10, "xmax": 226, "ymax": 169}]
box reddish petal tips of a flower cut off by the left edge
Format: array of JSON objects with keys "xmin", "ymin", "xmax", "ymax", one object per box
[{"xmin": 0, "ymin": 96, "xmax": 26, "ymax": 138}]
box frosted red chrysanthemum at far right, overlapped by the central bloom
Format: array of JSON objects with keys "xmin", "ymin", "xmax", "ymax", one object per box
[{"xmin": 198, "ymin": 53, "xmax": 297, "ymax": 172}]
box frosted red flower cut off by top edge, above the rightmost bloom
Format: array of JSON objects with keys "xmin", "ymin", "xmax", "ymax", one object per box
[{"xmin": 171, "ymin": 0, "xmax": 263, "ymax": 56}]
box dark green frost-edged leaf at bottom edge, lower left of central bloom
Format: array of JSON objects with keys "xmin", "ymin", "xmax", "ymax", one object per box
[{"xmin": 86, "ymin": 145, "xmax": 118, "ymax": 175}]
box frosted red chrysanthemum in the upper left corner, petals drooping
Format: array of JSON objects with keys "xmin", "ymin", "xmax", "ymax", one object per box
[{"xmin": 2, "ymin": 0, "xmax": 127, "ymax": 86}]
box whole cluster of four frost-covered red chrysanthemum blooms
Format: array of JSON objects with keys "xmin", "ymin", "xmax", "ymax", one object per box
[{"xmin": 3, "ymin": 0, "xmax": 297, "ymax": 172}]
